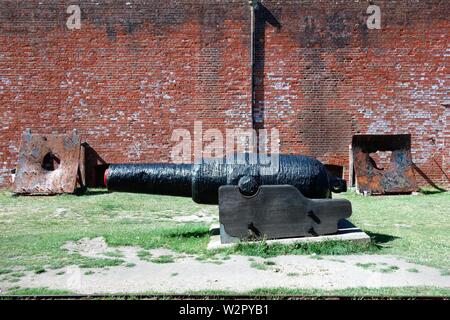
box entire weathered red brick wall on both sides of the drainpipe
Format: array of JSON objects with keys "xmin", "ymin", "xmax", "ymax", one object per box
[{"xmin": 0, "ymin": 0, "xmax": 450, "ymax": 185}]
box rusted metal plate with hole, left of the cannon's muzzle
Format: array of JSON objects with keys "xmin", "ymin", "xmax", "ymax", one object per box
[{"xmin": 13, "ymin": 130, "xmax": 81, "ymax": 195}]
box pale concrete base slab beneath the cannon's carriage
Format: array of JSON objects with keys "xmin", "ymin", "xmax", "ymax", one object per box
[{"xmin": 208, "ymin": 220, "xmax": 370, "ymax": 250}]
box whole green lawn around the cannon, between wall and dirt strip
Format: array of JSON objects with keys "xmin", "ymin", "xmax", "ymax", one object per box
[{"xmin": 0, "ymin": 186, "xmax": 450, "ymax": 274}]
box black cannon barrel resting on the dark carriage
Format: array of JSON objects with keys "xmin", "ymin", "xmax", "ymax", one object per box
[{"xmin": 105, "ymin": 153, "xmax": 346, "ymax": 204}]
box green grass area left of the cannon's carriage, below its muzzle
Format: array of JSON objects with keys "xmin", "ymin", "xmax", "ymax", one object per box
[{"xmin": 0, "ymin": 190, "xmax": 211, "ymax": 270}]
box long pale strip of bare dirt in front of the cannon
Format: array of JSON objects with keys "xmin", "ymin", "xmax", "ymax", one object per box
[{"xmin": 0, "ymin": 238, "xmax": 450, "ymax": 294}]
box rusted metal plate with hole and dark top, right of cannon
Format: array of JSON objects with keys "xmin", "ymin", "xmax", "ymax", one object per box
[{"xmin": 352, "ymin": 135, "xmax": 417, "ymax": 194}]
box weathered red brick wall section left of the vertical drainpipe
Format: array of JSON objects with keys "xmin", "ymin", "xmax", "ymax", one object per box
[{"xmin": 0, "ymin": 0, "xmax": 251, "ymax": 184}]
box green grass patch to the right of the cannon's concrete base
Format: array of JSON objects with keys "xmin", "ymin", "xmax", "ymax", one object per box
[{"xmin": 335, "ymin": 192, "xmax": 450, "ymax": 270}]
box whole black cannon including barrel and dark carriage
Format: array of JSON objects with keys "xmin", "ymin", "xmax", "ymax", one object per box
[{"xmin": 105, "ymin": 153, "xmax": 351, "ymax": 242}]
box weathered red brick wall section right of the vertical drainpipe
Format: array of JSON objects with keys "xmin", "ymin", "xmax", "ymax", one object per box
[{"xmin": 257, "ymin": 0, "xmax": 450, "ymax": 185}]
